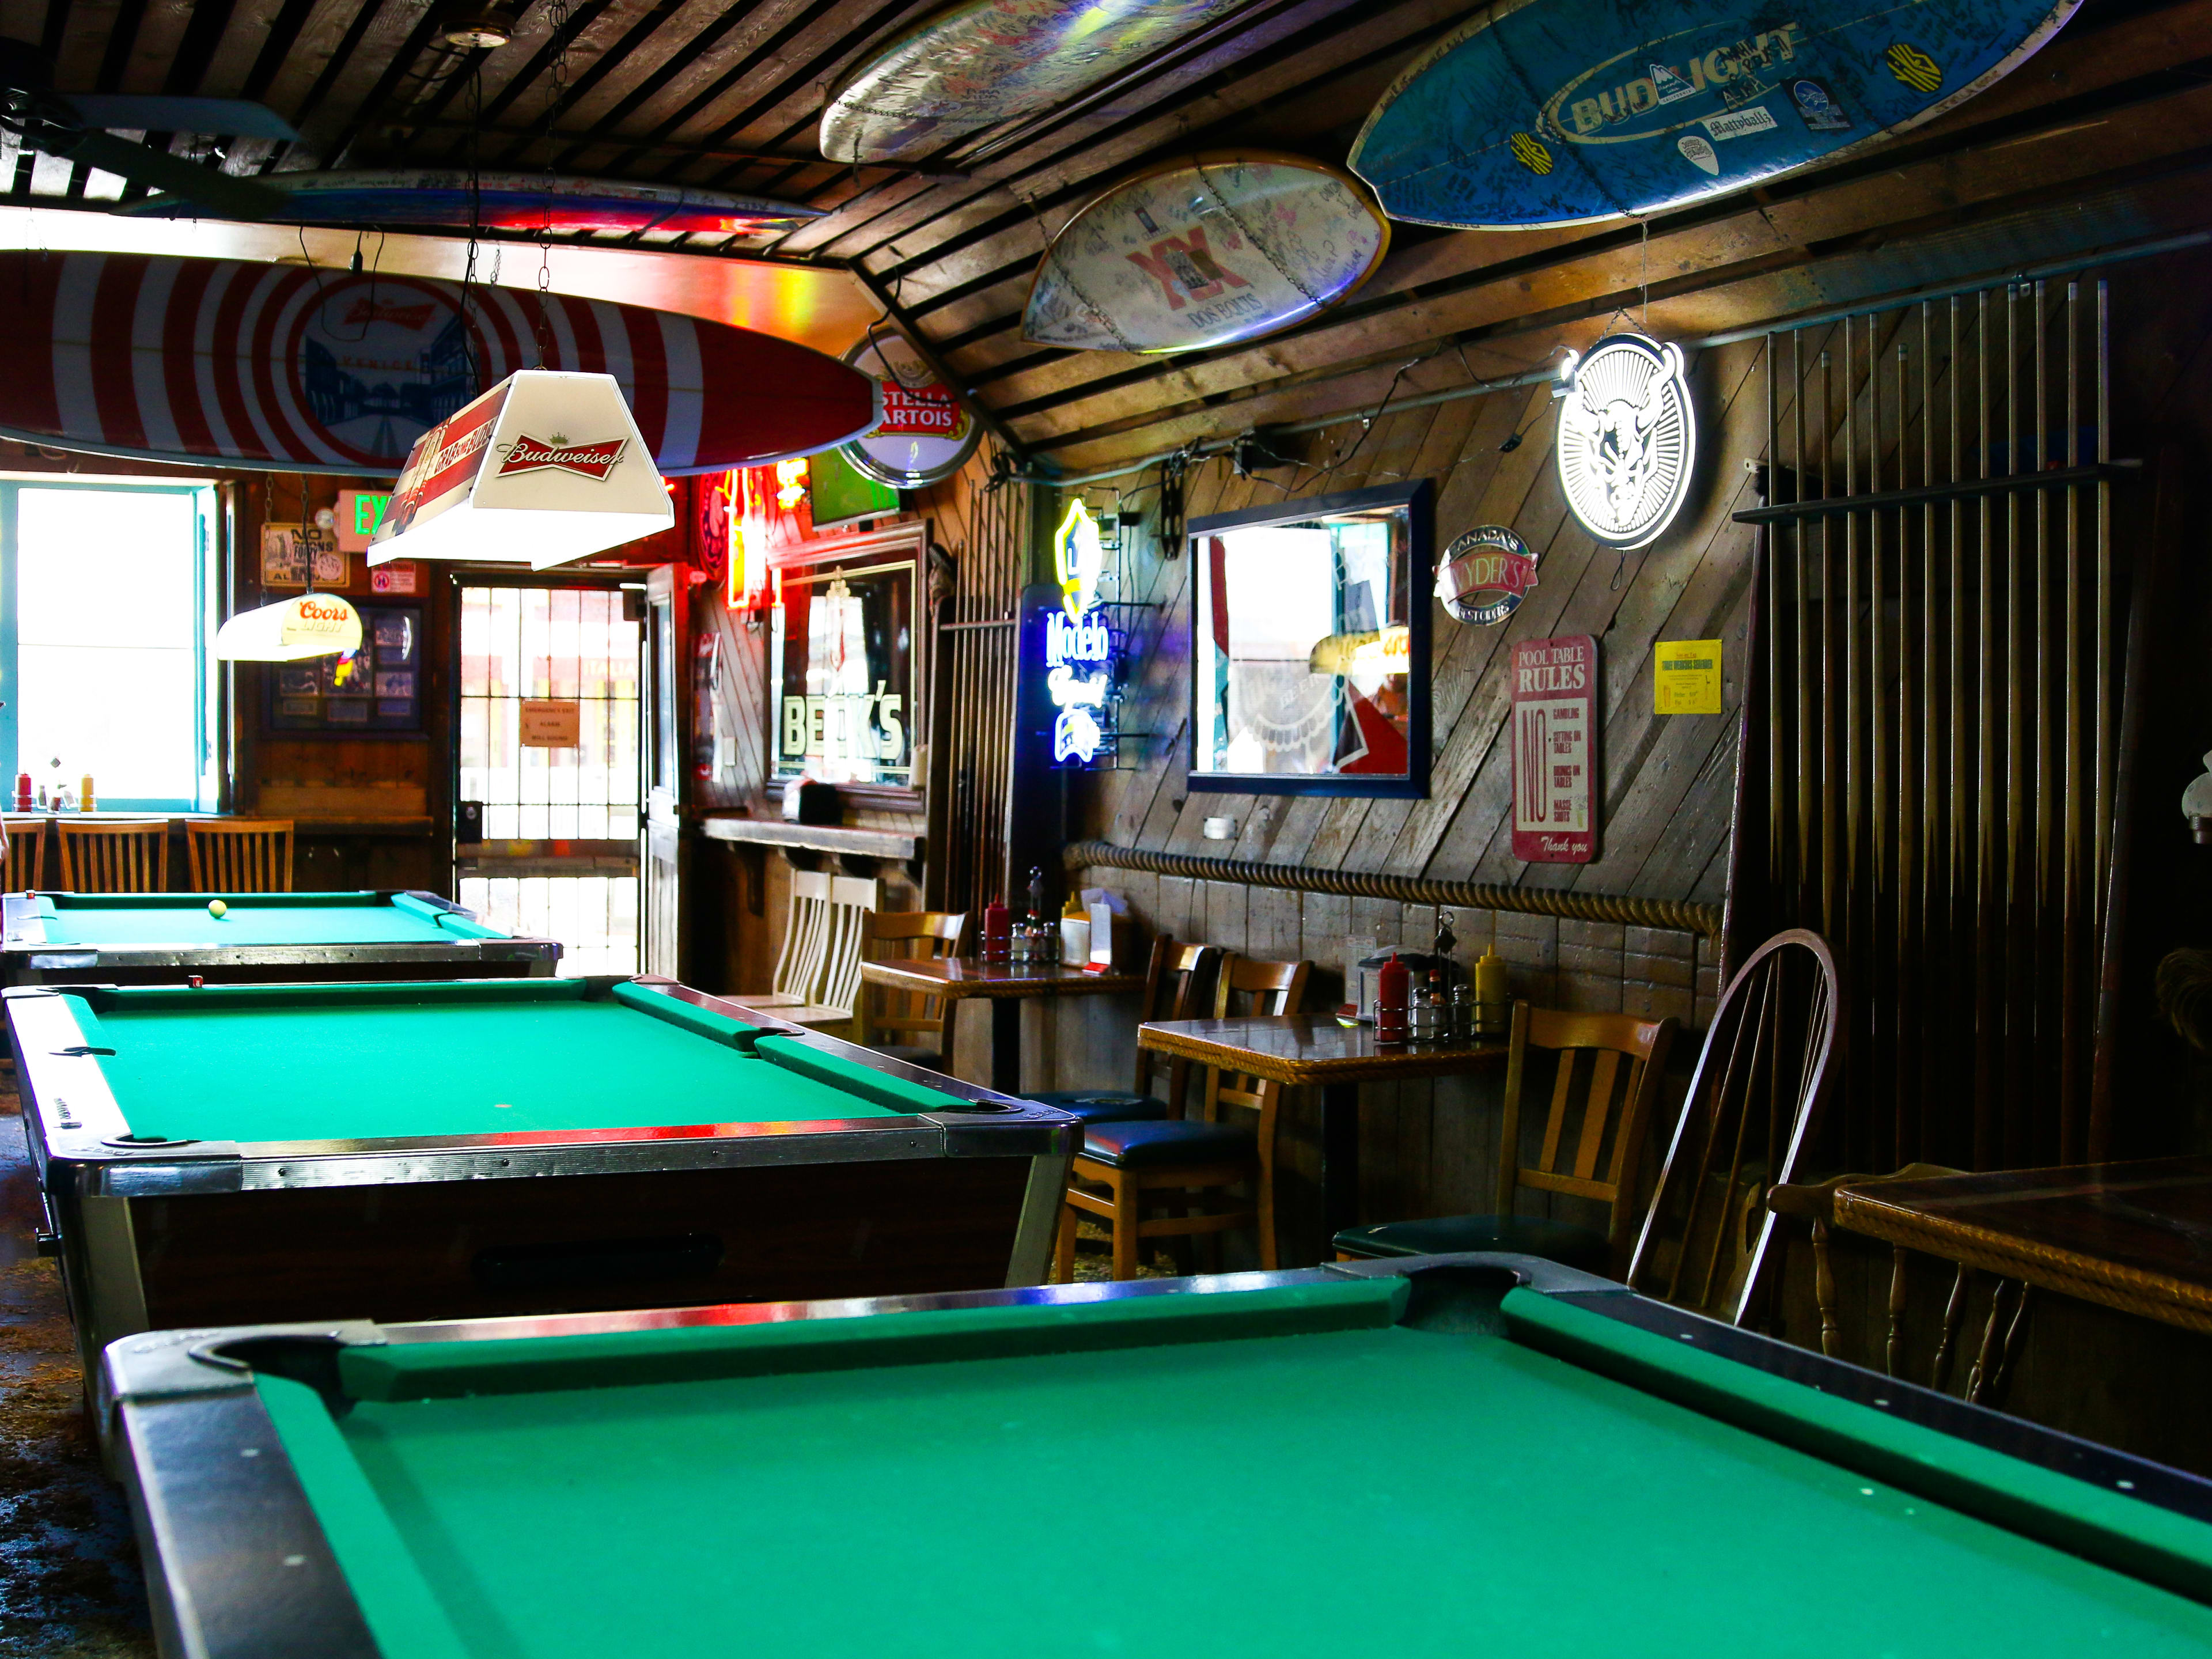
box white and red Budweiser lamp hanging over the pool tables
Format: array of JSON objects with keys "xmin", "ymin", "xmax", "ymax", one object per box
[{"xmin": 369, "ymin": 369, "xmax": 675, "ymax": 571}]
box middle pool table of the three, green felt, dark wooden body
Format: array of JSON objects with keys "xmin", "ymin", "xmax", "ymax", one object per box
[{"xmin": 0, "ymin": 978, "xmax": 1075, "ymax": 1376}]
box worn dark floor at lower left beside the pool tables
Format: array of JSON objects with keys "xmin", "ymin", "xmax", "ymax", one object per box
[{"xmin": 0, "ymin": 1092, "xmax": 155, "ymax": 1659}]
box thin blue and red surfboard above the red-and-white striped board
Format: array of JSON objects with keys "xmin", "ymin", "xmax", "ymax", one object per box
[{"xmin": 124, "ymin": 168, "xmax": 821, "ymax": 237}]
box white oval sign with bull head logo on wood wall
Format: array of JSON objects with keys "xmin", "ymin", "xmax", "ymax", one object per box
[{"xmin": 1557, "ymin": 334, "xmax": 1696, "ymax": 548}]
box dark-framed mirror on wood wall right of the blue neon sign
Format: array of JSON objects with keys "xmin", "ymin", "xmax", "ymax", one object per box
[{"xmin": 1185, "ymin": 480, "xmax": 1435, "ymax": 798}]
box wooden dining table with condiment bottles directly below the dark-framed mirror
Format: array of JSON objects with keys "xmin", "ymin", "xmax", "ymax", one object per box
[{"xmin": 1137, "ymin": 1013, "xmax": 1506, "ymax": 1238}]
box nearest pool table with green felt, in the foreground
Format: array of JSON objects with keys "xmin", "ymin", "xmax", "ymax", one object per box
[{"xmin": 104, "ymin": 1256, "xmax": 2212, "ymax": 1659}]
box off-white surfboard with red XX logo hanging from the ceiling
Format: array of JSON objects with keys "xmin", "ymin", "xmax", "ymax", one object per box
[{"xmin": 1022, "ymin": 150, "xmax": 1389, "ymax": 352}]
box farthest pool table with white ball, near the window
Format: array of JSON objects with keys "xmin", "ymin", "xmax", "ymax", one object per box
[{"xmin": 0, "ymin": 892, "xmax": 560, "ymax": 984}]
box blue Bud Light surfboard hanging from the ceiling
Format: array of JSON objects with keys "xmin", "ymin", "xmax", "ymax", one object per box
[{"xmin": 1351, "ymin": 0, "xmax": 2080, "ymax": 228}]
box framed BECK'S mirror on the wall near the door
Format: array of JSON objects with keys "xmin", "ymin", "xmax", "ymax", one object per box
[{"xmin": 767, "ymin": 524, "xmax": 929, "ymax": 792}]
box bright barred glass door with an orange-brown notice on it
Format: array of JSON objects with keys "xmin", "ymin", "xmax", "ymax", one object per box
[{"xmin": 453, "ymin": 577, "xmax": 646, "ymax": 974}]
